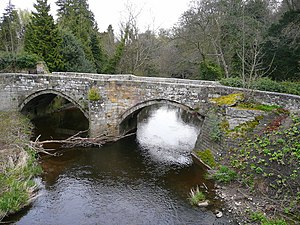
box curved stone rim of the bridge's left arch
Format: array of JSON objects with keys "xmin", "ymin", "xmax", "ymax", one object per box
[{"xmin": 19, "ymin": 89, "xmax": 89, "ymax": 120}]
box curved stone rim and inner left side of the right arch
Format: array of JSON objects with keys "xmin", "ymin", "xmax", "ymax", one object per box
[{"xmin": 118, "ymin": 99, "xmax": 204, "ymax": 135}]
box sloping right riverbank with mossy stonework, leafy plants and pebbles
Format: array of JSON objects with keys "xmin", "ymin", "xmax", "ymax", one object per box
[{"xmin": 194, "ymin": 94, "xmax": 300, "ymax": 225}]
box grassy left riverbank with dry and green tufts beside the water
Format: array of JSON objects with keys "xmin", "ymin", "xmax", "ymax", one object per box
[{"xmin": 0, "ymin": 112, "xmax": 41, "ymax": 221}]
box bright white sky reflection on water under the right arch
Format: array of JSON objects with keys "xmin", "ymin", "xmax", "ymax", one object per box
[{"xmin": 137, "ymin": 106, "xmax": 199, "ymax": 164}]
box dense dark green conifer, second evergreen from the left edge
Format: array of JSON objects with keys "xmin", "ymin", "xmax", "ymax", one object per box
[{"xmin": 25, "ymin": 0, "xmax": 63, "ymax": 71}]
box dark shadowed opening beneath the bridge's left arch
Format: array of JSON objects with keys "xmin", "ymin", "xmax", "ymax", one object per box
[{"xmin": 19, "ymin": 90, "xmax": 90, "ymax": 140}]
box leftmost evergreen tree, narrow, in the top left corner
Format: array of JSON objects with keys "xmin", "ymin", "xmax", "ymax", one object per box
[{"xmin": 0, "ymin": 1, "xmax": 22, "ymax": 53}]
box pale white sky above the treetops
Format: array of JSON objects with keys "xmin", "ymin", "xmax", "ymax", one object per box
[{"xmin": 0, "ymin": 0, "xmax": 191, "ymax": 32}]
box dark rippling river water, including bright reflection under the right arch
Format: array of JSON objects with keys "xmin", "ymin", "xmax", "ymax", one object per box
[{"xmin": 9, "ymin": 106, "xmax": 232, "ymax": 225}]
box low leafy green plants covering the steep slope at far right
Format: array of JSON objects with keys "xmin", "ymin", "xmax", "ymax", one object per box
[{"xmin": 229, "ymin": 112, "xmax": 300, "ymax": 221}]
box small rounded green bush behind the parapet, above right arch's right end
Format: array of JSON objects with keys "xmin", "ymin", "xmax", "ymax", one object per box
[{"xmin": 199, "ymin": 61, "xmax": 223, "ymax": 80}]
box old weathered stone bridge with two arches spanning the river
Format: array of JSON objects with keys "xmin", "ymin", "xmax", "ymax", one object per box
[{"xmin": 0, "ymin": 73, "xmax": 300, "ymax": 136}]
